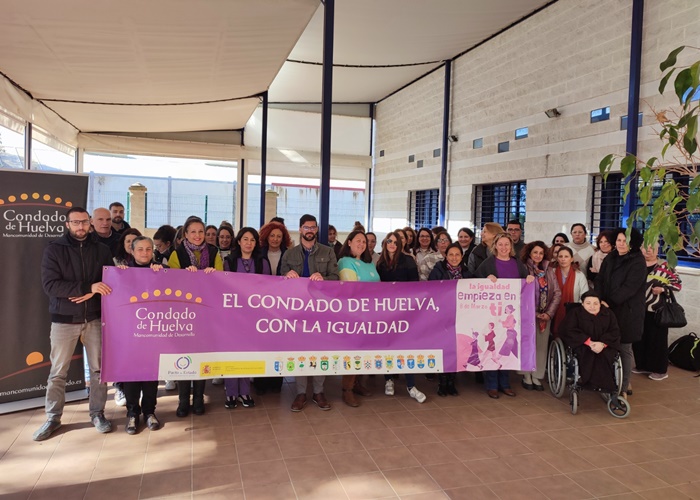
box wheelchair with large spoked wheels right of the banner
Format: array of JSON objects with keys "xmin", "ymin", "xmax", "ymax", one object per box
[{"xmin": 547, "ymin": 338, "xmax": 631, "ymax": 418}]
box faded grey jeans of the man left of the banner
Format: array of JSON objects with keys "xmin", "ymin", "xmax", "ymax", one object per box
[{"xmin": 46, "ymin": 319, "xmax": 107, "ymax": 420}]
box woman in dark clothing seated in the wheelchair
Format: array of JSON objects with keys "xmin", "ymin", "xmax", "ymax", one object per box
[{"xmin": 559, "ymin": 291, "xmax": 620, "ymax": 400}]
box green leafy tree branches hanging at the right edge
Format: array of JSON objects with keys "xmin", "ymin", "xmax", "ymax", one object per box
[{"xmin": 600, "ymin": 46, "xmax": 700, "ymax": 266}]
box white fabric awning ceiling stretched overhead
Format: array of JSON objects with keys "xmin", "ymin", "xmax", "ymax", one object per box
[{"xmin": 0, "ymin": 0, "xmax": 548, "ymax": 136}]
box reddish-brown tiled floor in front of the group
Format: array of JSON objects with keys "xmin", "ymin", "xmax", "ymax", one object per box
[{"xmin": 0, "ymin": 368, "xmax": 700, "ymax": 500}]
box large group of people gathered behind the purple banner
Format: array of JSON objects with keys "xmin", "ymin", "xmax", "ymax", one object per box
[{"xmin": 34, "ymin": 207, "xmax": 681, "ymax": 441}]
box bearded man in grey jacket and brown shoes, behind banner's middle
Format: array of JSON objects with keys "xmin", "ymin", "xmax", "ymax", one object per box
[{"xmin": 280, "ymin": 214, "xmax": 338, "ymax": 412}]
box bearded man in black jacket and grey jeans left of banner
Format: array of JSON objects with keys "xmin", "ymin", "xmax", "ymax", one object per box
[{"xmin": 33, "ymin": 207, "xmax": 112, "ymax": 441}]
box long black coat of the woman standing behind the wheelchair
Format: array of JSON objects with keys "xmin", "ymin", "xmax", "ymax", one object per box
[{"xmin": 595, "ymin": 250, "xmax": 647, "ymax": 344}]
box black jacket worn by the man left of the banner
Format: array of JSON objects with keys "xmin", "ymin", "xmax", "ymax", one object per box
[{"xmin": 41, "ymin": 233, "xmax": 114, "ymax": 323}]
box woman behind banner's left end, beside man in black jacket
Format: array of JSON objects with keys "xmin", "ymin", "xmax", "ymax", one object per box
[{"xmin": 117, "ymin": 236, "xmax": 163, "ymax": 435}]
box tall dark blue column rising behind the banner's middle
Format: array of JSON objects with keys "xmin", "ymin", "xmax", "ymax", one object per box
[{"xmin": 318, "ymin": 0, "xmax": 335, "ymax": 244}]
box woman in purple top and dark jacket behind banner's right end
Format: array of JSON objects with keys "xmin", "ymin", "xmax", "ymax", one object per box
[{"xmin": 472, "ymin": 233, "xmax": 535, "ymax": 399}]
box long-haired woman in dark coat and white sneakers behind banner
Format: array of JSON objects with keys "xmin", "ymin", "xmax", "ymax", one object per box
[{"xmin": 377, "ymin": 231, "xmax": 425, "ymax": 403}]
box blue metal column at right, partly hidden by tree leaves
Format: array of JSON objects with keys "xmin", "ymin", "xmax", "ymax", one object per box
[{"xmin": 622, "ymin": 0, "xmax": 644, "ymax": 226}]
